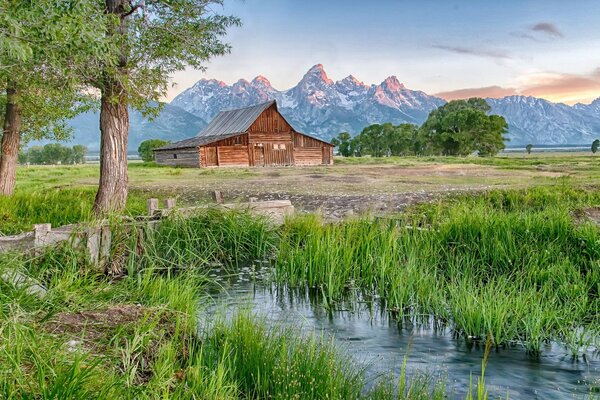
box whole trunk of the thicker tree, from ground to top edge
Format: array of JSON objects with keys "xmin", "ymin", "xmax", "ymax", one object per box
[{"xmin": 94, "ymin": 0, "xmax": 129, "ymax": 215}]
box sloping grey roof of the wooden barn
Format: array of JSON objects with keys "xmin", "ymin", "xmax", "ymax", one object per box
[{"xmin": 155, "ymin": 100, "xmax": 329, "ymax": 150}]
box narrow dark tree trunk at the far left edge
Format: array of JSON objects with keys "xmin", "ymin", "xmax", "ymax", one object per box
[{"xmin": 0, "ymin": 83, "xmax": 21, "ymax": 196}]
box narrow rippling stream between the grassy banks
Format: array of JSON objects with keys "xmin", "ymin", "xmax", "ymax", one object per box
[{"xmin": 211, "ymin": 269, "xmax": 600, "ymax": 399}]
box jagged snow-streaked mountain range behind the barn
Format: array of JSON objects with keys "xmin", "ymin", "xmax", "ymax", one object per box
[{"xmin": 57, "ymin": 64, "xmax": 600, "ymax": 149}]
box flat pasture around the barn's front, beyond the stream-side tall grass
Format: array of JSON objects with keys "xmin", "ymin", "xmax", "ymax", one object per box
[{"xmin": 0, "ymin": 153, "xmax": 600, "ymax": 234}]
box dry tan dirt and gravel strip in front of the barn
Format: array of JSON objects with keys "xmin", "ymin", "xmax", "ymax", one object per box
[{"xmin": 131, "ymin": 163, "xmax": 565, "ymax": 219}]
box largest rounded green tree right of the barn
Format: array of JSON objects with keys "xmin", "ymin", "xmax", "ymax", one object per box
[{"xmin": 421, "ymin": 98, "xmax": 508, "ymax": 156}]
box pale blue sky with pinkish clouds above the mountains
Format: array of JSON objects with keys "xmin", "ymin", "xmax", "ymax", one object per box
[{"xmin": 167, "ymin": 0, "xmax": 600, "ymax": 104}]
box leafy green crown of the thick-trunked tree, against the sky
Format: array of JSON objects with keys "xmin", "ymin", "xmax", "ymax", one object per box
[{"xmin": 86, "ymin": 0, "xmax": 240, "ymax": 114}]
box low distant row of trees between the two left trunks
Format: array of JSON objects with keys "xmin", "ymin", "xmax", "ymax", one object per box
[{"xmin": 19, "ymin": 143, "xmax": 87, "ymax": 165}]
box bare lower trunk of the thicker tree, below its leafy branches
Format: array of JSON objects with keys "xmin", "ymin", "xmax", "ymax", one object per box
[{"xmin": 94, "ymin": 81, "xmax": 129, "ymax": 215}]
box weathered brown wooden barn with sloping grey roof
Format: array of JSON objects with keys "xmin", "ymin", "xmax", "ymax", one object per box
[{"xmin": 154, "ymin": 100, "xmax": 333, "ymax": 167}]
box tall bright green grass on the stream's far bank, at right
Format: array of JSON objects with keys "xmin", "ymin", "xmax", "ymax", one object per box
[{"xmin": 277, "ymin": 187, "xmax": 600, "ymax": 356}]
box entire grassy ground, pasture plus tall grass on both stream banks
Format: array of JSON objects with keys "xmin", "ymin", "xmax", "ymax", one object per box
[{"xmin": 0, "ymin": 153, "xmax": 600, "ymax": 399}]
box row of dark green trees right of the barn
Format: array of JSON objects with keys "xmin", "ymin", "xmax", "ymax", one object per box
[{"xmin": 331, "ymin": 98, "xmax": 508, "ymax": 157}]
